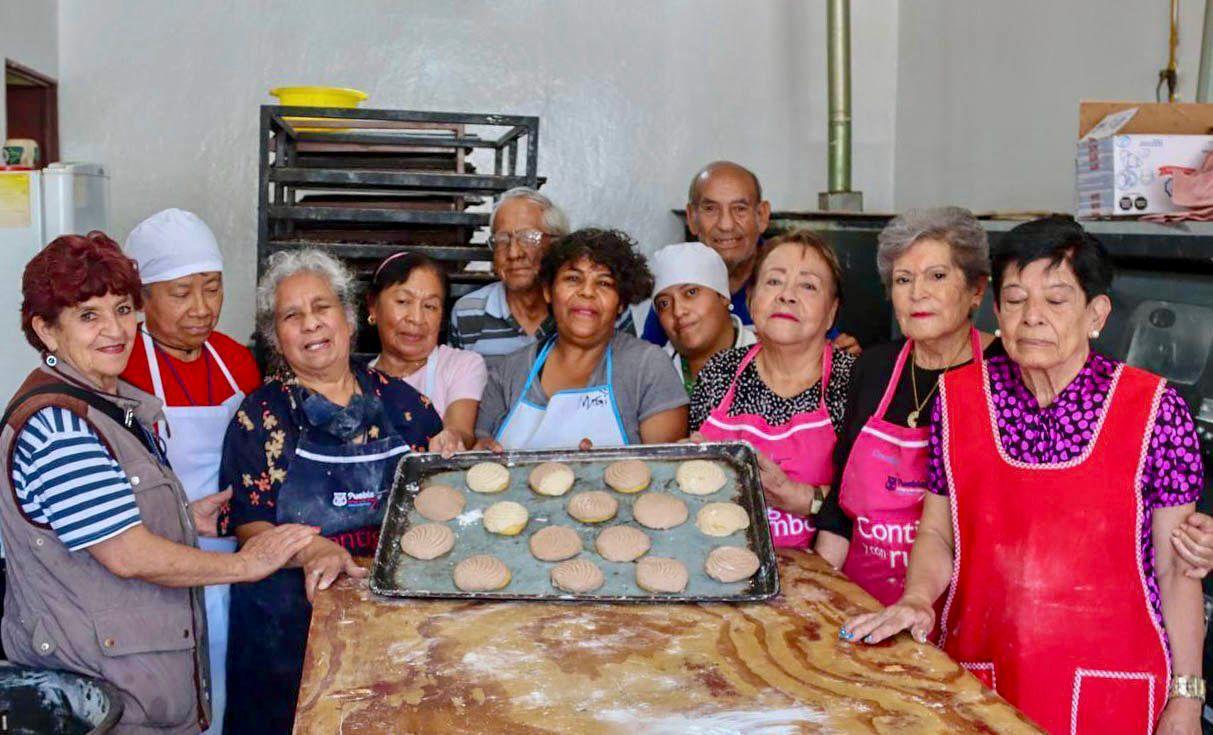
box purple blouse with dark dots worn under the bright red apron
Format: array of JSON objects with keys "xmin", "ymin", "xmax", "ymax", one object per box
[{"xmin": 927, "ymin": 352, "xmax": 1205, "ymax": 626}]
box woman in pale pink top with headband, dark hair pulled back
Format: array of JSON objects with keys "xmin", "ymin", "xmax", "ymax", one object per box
[{"xmin": 366, "ymin": 252, "xmax": 488, "ymax": 452}]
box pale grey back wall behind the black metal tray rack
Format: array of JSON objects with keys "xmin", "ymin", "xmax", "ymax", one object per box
[{"xmin": 59, "ymin": 0, "xmax": 898, "ymax": 335}]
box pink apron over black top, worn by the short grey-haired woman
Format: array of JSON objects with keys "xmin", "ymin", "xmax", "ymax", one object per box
[{"xmin": 838, "ymin": 329, "xmax": 981, "ymax": 605}]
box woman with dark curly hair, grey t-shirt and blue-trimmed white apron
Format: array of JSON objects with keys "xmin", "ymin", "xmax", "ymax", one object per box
[{"xmin": 475, "ymin": 229, "xmax": 687, "ymax": 450}]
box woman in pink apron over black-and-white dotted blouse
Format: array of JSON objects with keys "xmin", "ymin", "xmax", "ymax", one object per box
[{"xmin": 690, "ymin": 230, "xmax": 855, "ymax": 548}]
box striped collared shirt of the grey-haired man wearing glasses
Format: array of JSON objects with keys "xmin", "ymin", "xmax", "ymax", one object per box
[{"xmin": 446, "ymin": 280, "xmax": 636, "ymax": 358}]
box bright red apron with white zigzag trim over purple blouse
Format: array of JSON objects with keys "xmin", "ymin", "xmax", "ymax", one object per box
[{"xmin": 939, "ymin": 365, "xmax": 1171, "ymax": 735}]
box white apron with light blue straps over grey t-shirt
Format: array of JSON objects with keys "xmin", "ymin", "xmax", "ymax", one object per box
[{"xmin": 496, "ymin": 340, "xmax": 627, "ymax": 449}]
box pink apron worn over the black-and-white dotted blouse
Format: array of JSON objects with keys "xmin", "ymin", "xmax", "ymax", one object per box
[{"xmin": 699, "ymin": 342, "xmax": 838, "ymax": 548}]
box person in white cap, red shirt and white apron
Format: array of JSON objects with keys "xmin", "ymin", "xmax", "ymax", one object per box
[{"xmin": 123, "ymin": 209, "xmax": 261, "ymax": 734}]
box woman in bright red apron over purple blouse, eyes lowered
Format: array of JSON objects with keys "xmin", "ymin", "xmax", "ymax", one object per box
[{"xmin": 841, "ymin": 217, "xmax": 1205, "ymax": 734}]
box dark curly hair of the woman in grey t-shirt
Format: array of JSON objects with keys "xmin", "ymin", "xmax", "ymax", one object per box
[{"xmin": 539, "ymin": 227, "xmax": 653, "ymax": 306}]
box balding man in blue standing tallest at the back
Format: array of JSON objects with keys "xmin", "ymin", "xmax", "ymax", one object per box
[{"xmin": 640, "ymin": 161, "xmax": 859, "ymax": 353}]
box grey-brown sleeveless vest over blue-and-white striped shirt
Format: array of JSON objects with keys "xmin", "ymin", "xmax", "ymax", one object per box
[{"xmin": 0, "ymin": 364, "xmax": 210, "ymax": 734}]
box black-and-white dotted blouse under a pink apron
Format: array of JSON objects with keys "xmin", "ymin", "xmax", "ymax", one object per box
[{"xmin": 690, "ymin": 347, "xmax": 855, "ymax": 432}]
